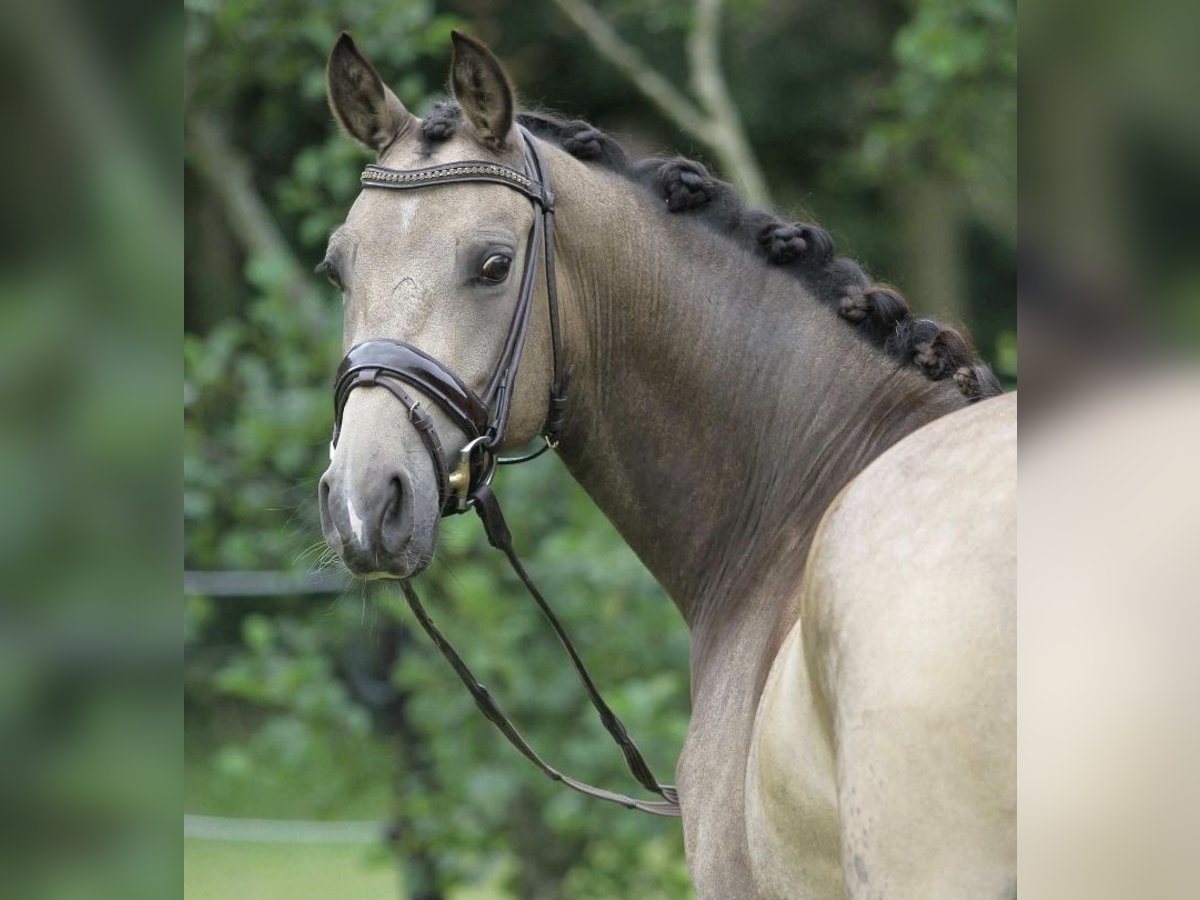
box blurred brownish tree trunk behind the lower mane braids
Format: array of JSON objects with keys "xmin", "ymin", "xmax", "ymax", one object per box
[{"xmin": 889, "ymin": 173, "xmax": 971, "ymax": 323}]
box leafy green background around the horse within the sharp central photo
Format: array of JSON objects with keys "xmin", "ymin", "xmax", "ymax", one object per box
[{"xmin": 184, "ymin": 0, "xmax": 1016, "ymax": 900}]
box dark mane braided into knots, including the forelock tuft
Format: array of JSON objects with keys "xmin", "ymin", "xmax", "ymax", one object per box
[{"xmin": 421, "ymin": 101, "xmax": 1002, "ymax": 402}]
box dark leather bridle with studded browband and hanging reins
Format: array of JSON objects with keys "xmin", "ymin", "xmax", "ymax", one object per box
[{"xmin": 334, "ymin": 127, "xmax": 679, "ymax": 816}]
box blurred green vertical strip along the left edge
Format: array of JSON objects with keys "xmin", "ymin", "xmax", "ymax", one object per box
[{"xmin": 0, "ymin": 2, "xmax": 182, "ymax": 900}]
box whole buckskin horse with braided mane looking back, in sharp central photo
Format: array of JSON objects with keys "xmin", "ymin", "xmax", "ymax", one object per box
[{"xmin": 318, "ymin": 32, "xmax": 1016, "ymax": 900}]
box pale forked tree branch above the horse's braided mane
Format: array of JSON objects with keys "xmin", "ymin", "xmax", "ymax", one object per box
[{"xmin": 554, "ymin": 0, "xmax": 770, "ymax": 205}]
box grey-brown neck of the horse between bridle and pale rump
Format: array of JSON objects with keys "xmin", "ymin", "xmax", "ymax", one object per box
[{"xmin": 544, "ymin": 152, "xmax": 965, "ymax": 646}]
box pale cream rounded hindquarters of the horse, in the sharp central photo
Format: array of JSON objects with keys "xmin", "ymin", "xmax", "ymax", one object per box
[{"xmin": 746, "ymin": 395, "xmax": 1016, "ymax": 896}]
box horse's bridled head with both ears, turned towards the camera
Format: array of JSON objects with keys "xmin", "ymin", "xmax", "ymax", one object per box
[{"xmin": 318, "ymin": 32, "xmax": 557, "ymax": 577}]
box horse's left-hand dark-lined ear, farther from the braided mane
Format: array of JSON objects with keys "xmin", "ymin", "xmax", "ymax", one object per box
[{"xmin": 325, "ymin": 31, "xmax": 413, "ymax": 152}]
